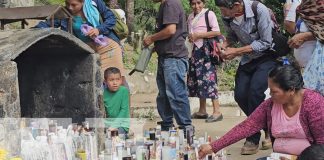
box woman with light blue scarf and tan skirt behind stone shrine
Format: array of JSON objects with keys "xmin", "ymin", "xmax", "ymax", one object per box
[{"xmin": 35, "ymin": 0, "xmax": 127, "ymax": 85}]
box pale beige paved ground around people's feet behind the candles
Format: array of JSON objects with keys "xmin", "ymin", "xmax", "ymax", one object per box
[{"xmin": 132, "ymin": 94, "xmax": 272, "ymax": 160}]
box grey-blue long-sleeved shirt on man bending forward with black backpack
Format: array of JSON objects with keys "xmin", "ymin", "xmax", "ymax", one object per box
[{"xmin": 224, "ymin": 0, "xmax": 273, "ymax": 65}]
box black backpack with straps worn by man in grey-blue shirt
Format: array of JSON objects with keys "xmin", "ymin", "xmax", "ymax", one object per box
[{"xmin": 252, "ymin": 1, "xmax": 290, "ymax": 58}]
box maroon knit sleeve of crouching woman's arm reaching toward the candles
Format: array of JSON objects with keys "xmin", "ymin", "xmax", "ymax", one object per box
[{"xmin": 211, "ymin": 99, "xmax": 271, "ymax": 153}]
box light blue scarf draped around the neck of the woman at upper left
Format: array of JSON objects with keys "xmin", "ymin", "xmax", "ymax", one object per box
[{"xmin": 83, "ymin": 0, "xmax": 100, "ymax": 28}]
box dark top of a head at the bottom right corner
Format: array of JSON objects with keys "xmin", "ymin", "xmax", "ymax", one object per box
[{"xmin": 298, "ymin": 144, "xmax": 324, "ymax": 160}]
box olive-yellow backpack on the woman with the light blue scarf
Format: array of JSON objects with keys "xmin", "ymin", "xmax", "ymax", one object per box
[{"xmin": 111, "ymin": 9, "xmax": 128, "ymax": 40}]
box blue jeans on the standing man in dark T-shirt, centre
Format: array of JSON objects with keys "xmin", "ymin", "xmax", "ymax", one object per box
[{"xmin": 156, "ymin": 57, "xmax": 191, "ymax": 129}]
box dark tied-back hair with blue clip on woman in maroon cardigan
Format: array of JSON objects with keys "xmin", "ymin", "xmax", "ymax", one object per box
[{"xmin": 268, "ymin": 58, "xmax": 304, "ymax": 91}]
